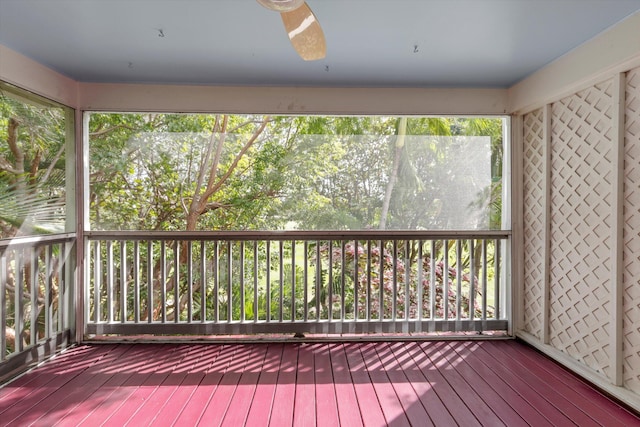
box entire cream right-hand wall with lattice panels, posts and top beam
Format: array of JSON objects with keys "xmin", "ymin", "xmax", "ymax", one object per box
[{"xmin": 509, "ymin": 15, "xmax": 640, "ymax": 409}]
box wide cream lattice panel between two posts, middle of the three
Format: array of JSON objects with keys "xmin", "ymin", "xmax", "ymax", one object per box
[{"xmin": 550, "ymin": 81, "xmax": 613, "ymax": 376}]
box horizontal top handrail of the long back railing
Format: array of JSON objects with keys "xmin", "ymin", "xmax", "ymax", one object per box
[{"xmin": 84, "ymin": 230, "xmax": 511, "ymax": 241}]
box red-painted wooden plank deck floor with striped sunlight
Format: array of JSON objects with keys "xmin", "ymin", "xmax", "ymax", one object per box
[{"xmin": 0, "ymin": 340, "xmax": 640, "ymax": 426}]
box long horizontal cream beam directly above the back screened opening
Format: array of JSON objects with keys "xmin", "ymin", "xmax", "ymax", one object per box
[{"xmin": 79, "ymin": 83, "xmax": 507, "ymax": 115}]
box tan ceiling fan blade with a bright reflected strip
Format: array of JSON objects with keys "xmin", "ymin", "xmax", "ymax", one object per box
[{"xmin": 280, "ymin": 3, "xmax": 327, "ymax": 61}]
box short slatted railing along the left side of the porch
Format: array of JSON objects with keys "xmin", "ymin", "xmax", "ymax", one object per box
[{"xmin": 0, "ymin": 233, "xmax": 75, "ymax": 378}]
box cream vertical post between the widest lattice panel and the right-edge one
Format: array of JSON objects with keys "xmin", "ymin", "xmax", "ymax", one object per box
[{"xmin": 610, "ymin": 73, "xmax": 626, "ymax": 386}]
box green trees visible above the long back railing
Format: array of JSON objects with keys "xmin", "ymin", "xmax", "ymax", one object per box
[{"xmin": 90, "ymin": 114, "xmax": 502, "ymax": 230}]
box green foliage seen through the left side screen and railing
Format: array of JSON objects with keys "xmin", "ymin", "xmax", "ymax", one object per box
[{"xmin": 0, "ymin": 89, "xmax": 67, "ymax": 354}]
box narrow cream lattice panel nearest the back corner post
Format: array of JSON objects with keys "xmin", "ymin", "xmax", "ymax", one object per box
[{"xmin": 523, "ymin": 109, "xmax": 545, "ymax": 339}]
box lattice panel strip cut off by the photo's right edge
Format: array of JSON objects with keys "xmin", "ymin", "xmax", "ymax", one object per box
[{"xmin": 622, "ymin": 68, "xmax": 640, "ymax": 393}]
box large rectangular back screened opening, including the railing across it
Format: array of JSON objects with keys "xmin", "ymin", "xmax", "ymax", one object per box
[{"xmin": 76, "ymin": 113, "xmax": 510, "ymax": 337}]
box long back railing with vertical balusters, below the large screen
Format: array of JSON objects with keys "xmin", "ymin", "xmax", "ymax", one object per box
[{"xmin": 84, "ymin": 231, "xmax": 510, "ymax": 335}]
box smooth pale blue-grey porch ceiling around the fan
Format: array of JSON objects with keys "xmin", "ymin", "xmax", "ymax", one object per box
[{"xmin": 0, "ymin": 0, "xmax": 640, "ymax": 87}]
